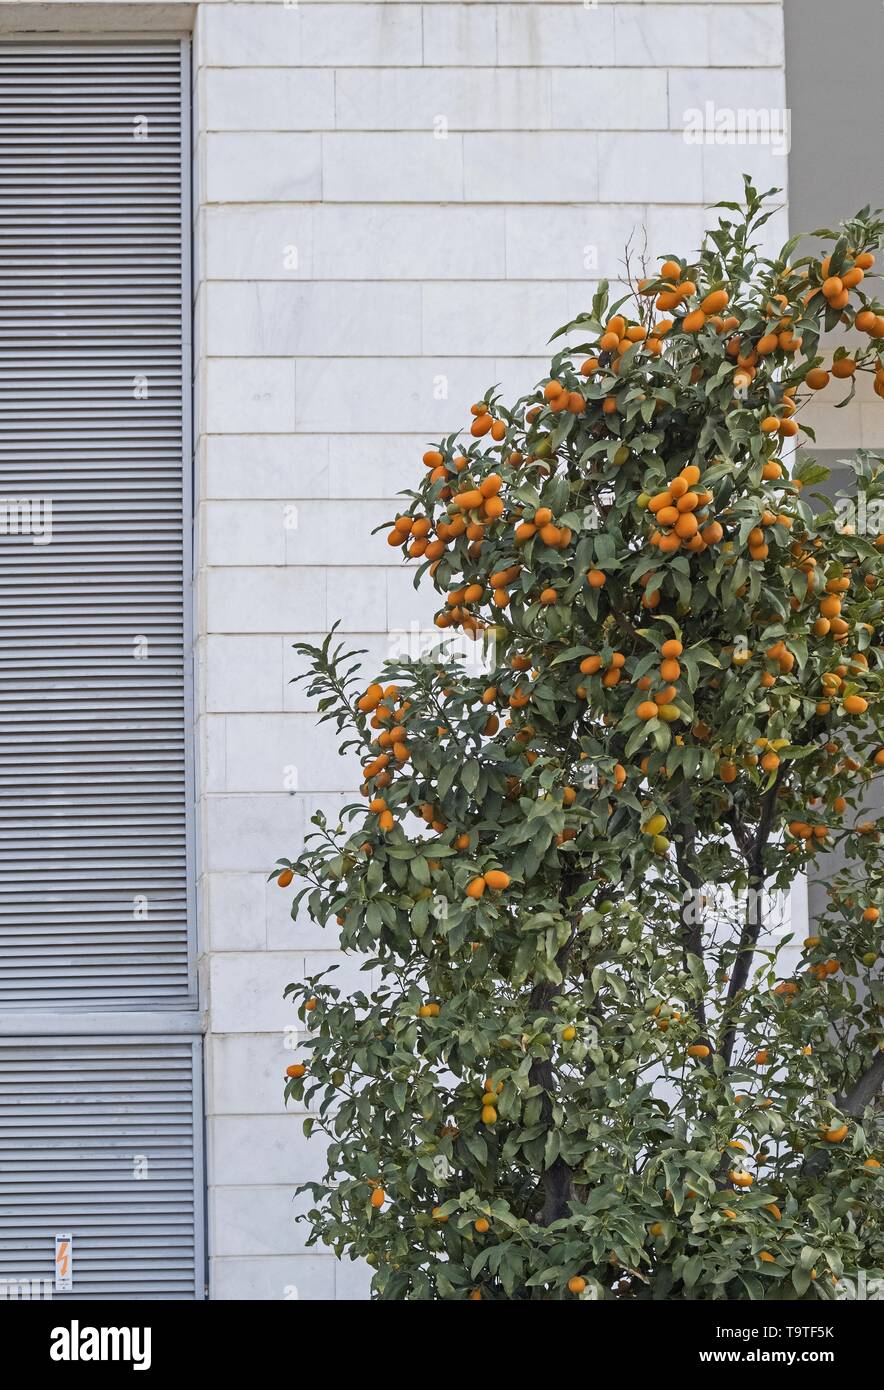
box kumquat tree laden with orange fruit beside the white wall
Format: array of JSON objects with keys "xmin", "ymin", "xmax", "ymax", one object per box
[{"xmin": 274, "ymin": 181, "xmax": 884, "ymax": 1301}]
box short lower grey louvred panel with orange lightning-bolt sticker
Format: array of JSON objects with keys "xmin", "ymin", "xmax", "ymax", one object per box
[{"xmin": 0, "ymin": 1037, "xmax": 204, "ymax": 1298}]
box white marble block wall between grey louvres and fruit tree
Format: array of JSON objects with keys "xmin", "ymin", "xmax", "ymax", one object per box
[{"xmin": 195, "ymin": 0, "xmax": 787, "ymax": 1300}]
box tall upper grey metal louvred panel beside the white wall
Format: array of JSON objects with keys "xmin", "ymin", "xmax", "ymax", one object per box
[{"xmin": 0, "ymin": 40, "xmax": 193, "ymax": 1009}]
